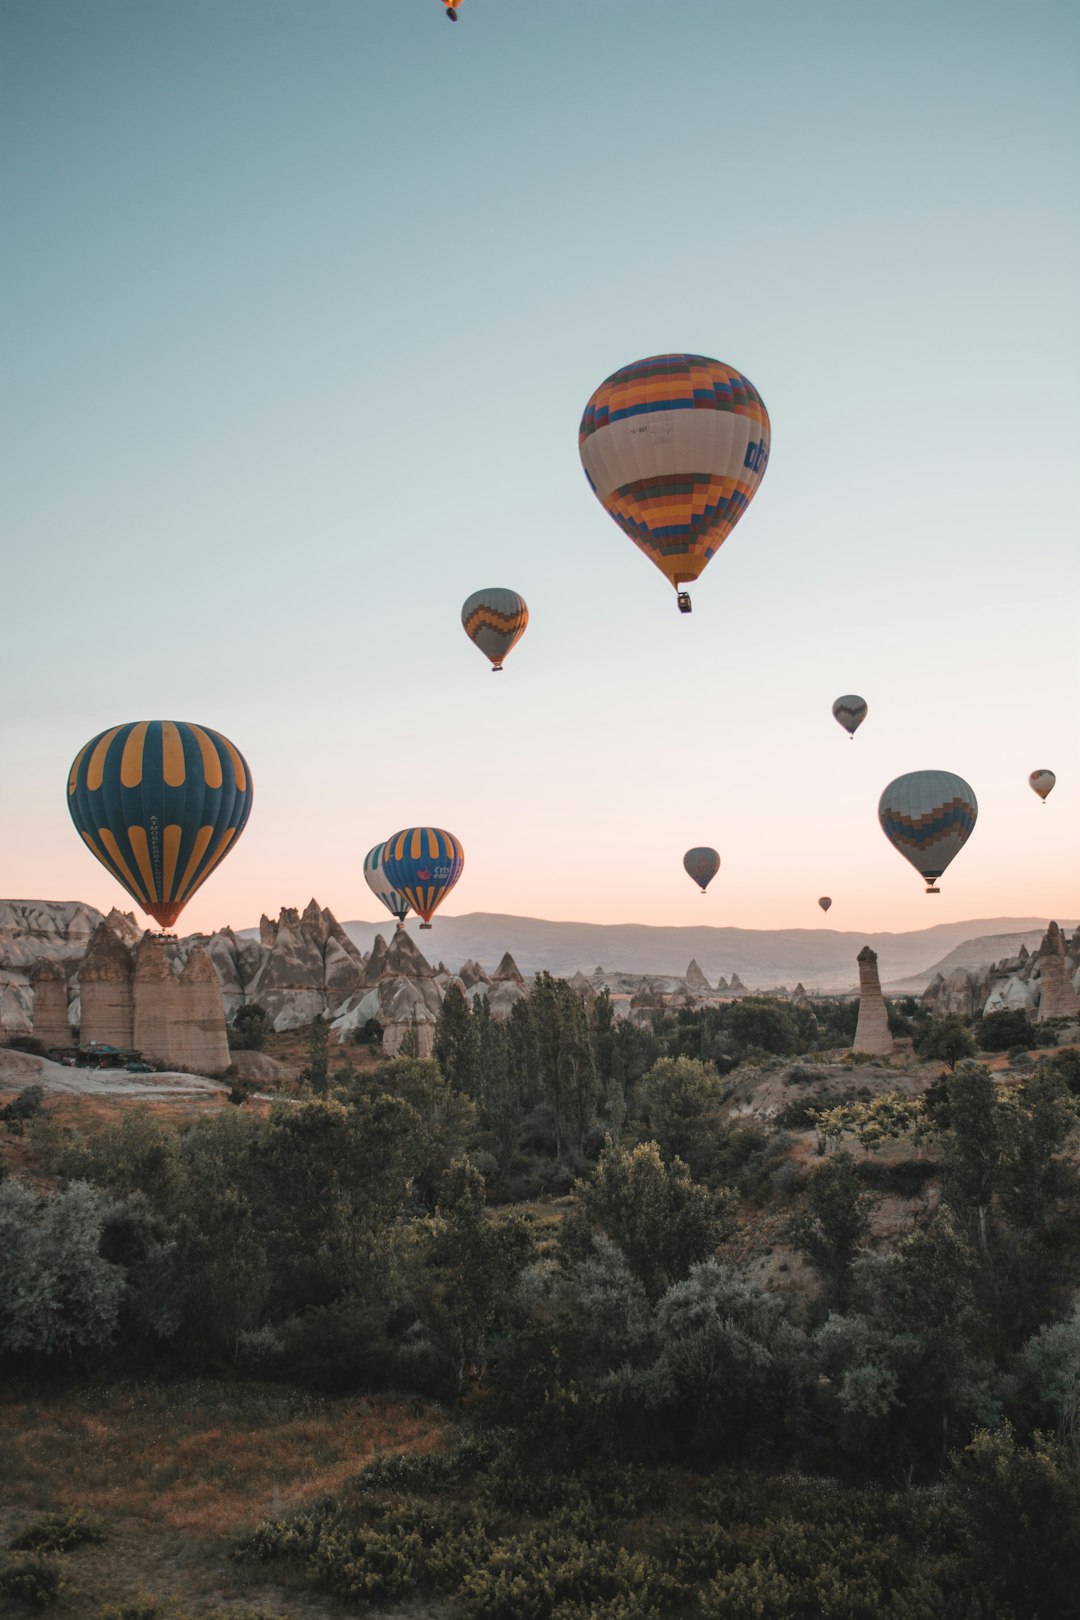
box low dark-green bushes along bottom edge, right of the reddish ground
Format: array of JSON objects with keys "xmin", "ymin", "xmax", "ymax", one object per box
[{"xmin": 236, "ymin": 1429, "xmax": 1080, "ymax": 1620}]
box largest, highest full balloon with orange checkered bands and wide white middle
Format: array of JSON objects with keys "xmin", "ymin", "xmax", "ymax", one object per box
[{"xmin": 578, "ymin": 355, "xmax": 769, "ymax": 612}]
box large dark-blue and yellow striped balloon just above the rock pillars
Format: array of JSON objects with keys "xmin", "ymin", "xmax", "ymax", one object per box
[{"xmin": 68, "ymin": 719, "xmax": 251, "ymax": 928}]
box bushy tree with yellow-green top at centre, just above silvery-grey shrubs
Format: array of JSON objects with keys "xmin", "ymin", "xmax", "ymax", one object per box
[{"xmin": 560, "ymin": 1142, "xmax": 733, "ymax": 1299}]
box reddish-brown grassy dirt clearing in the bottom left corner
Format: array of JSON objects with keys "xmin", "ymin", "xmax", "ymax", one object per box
[{"xmin": 0, "ymin": 1380, "xmax": 447, "ymax": 1620}]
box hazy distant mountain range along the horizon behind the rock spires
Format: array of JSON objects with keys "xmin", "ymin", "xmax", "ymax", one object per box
[{"xmin": 335, "ymin": 912, "xmax": 1065, "ymax": 991}]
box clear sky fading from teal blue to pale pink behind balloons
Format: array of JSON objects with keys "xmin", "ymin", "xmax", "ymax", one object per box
[{"xmin": 0, "ymin": 0, "xmax": 1080, "ymax": 940}]
